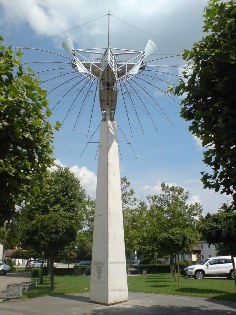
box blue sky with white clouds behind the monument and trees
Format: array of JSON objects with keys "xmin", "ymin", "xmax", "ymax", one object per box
[{"xmin": 0, "ymin": 0, "xmax": 231, "ymax": 212}]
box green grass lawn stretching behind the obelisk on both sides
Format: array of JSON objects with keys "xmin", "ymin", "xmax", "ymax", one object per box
[{"xmin": 24, "ymin": 273, "xmax": 236, "ymax": 301}]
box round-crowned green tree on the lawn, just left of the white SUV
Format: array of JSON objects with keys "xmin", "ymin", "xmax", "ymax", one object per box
[{"xmin": 146, "ymin": 183, "xmax": 202, "ymax": 274}]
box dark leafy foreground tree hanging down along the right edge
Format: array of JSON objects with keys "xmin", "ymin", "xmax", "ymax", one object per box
[{"xmin": 175, "ymin": 0, "xmax": 236, "ymax": 208}]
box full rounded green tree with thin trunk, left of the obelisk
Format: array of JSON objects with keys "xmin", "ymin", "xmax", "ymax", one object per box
[{"xmin": 21, "ymin": 168, "xmax": 87, "ymax": 288}]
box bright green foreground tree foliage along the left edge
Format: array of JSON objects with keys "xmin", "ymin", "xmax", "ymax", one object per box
[{"xmin": 0, "ymin": 37, "xmax": 58, "ymax": 226}]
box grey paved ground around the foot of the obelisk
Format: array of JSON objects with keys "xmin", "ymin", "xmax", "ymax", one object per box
[{"xmin": 0, "ymin": 293, "xmax": 236, "ymax": 315}]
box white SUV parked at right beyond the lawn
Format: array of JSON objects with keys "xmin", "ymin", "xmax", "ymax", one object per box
[{"xmin": 185, "ymin": 256, "xmax": 235, "ymax": 279}]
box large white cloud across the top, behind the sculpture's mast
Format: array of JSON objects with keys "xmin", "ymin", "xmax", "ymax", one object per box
[{"xmin": 0, "ymin": 0, "xmax": 208, "ymax": 50}]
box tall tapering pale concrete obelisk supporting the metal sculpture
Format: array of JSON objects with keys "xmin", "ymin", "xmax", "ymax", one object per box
[{"xmin": 90, "ymin": 120, "xmax": 128, "ymax": 305}]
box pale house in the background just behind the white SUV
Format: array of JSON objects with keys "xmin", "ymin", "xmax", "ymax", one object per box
[{"xmin": 179, "ymin": 240, "xmax": 217, "ymax": 261}]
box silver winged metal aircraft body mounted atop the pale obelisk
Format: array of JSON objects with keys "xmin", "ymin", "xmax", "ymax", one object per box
[{"xmin": 63, "ymin": 38, "xmax": 157, "ymax": 120}]
